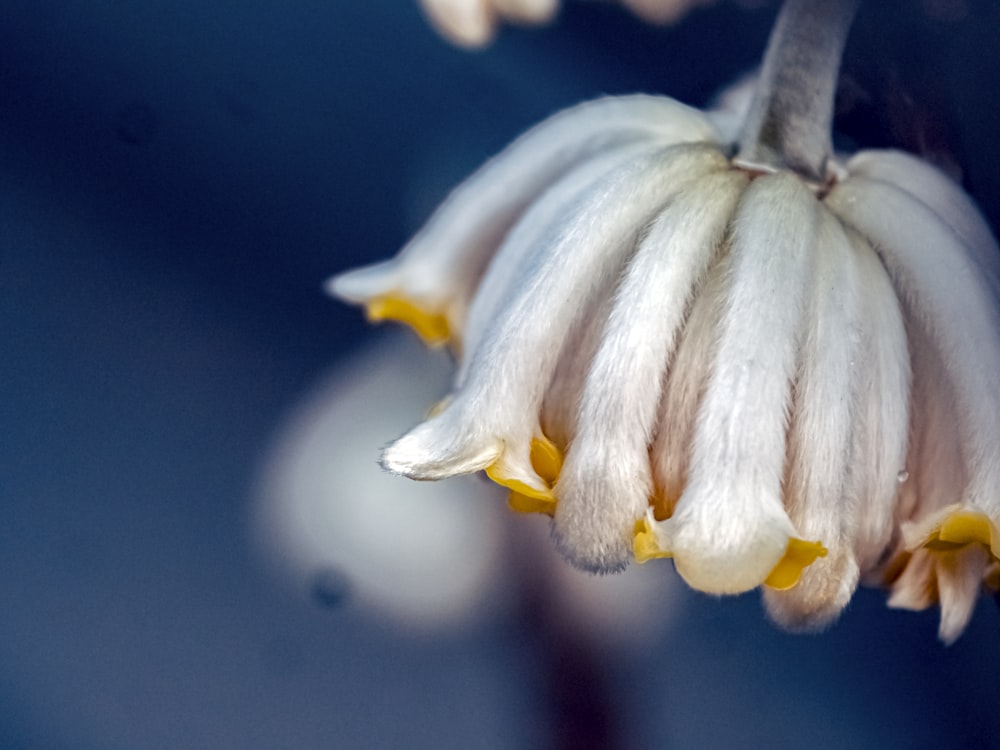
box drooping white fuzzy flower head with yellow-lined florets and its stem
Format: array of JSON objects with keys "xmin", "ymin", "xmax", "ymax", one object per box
[{"xmin": 332, "ymin": 0, "xmax": 1000, "ymax": 641}]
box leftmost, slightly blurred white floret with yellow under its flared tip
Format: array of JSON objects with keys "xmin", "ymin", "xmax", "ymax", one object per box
[{"xmin": 327, "ymin": 95, "xmax": 715, "ymax": 344}]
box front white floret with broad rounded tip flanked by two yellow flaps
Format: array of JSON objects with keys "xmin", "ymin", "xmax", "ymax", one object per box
[{"xmin": 656, "ymin": 173, "xmax": 817, "ymax": 593}]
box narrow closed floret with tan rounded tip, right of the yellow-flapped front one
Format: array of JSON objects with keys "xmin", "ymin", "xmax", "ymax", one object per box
[{"xmin": 764, "ymin": 206, "xmax": 864, "ymax": 630}]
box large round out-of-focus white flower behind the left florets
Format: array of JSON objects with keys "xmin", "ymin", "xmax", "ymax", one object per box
[{"xmin": 258, "ymin": 337, "xmax": 502, "ymax": 626}]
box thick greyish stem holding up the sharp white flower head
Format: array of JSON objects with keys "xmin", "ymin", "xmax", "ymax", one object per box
[{"xmin": 737, "ymin": 0, "xmax": 859, "ymax": 183}]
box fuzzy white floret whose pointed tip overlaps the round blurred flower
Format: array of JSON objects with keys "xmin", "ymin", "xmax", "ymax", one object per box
[{"xmin": 383, "ymin": 145, "xmax": 726, "ymax": 490}]
